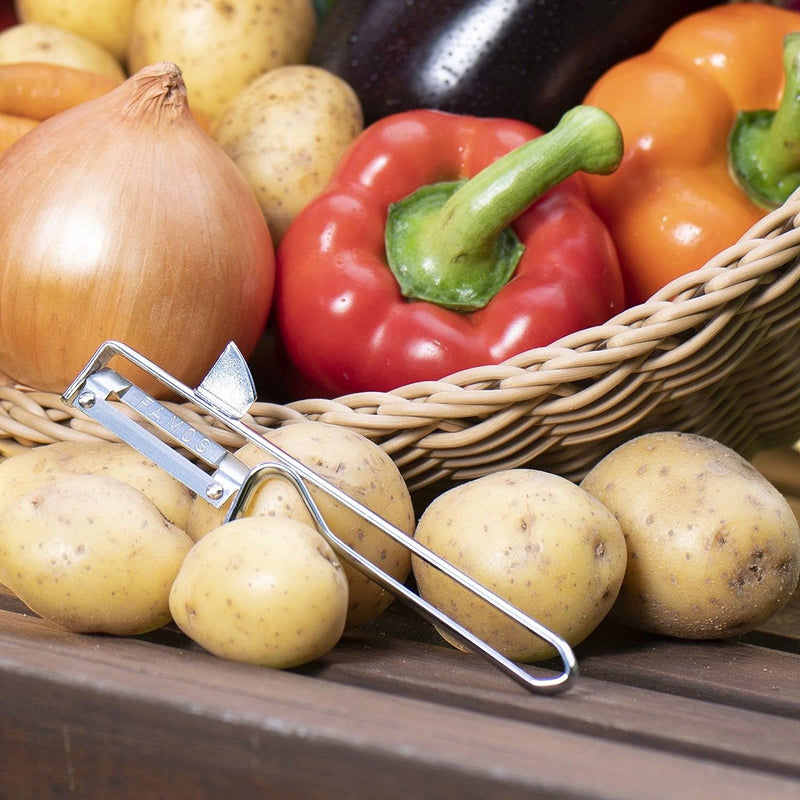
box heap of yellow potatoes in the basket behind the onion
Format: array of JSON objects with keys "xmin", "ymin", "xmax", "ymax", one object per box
[{"xmin": 6, "ymin": 0, "xmax": 364, "ymax": 244}]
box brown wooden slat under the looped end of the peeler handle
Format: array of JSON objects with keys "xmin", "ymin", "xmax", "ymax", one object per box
[{"xmin": 306, "ymin": 637, "xmax": 800, "ymax": 777}]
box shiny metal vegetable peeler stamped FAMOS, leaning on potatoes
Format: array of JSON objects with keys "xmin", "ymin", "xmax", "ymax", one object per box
[{"xmin": 61, "ymin": 341, "xmax": 578, "ymax": 694}]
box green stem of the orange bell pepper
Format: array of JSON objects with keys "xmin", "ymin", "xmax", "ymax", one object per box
[{"xmin": 729, "ymin": 33, "xmax": 800, "ymax": 208}]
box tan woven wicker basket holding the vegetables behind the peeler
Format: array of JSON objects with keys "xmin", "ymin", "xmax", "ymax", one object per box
[{"xmin": 0, "ymin": 192, "xmax": 800, "ymax": 491}]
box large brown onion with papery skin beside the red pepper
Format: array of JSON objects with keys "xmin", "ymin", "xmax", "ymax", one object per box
[{"xmin": 0, "ymin": 62, "xmax": 275, "ymax": 394}]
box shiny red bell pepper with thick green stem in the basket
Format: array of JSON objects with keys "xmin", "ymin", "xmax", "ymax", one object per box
[{"xmin": 275, "ymin": 106, "xmax": 624, "ymax": 396}]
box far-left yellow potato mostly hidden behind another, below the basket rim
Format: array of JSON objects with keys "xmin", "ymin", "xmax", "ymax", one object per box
[{"xmin": 0, "ymin": 441, "xmax": 194, "ymax": 530}]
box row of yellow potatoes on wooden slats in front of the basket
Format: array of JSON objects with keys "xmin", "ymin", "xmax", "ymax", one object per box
[{"xmin": 0, "ymin": 421, "xmax": 800, "ymax": 668}]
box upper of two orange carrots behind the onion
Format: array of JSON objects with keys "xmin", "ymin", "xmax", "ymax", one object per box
[{"xmin": 0, "ymin": 61, "xmax": 122, "ymax": 121}]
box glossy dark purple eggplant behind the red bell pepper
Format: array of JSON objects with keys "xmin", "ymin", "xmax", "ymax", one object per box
[{"xmin": 310, "ymin": 0, "xmax": 719, "ymax": 130}]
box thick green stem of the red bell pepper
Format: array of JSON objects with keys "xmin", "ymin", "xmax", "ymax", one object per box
[{"xmin": 386, "ymin": 106, "xmax": 623, "ymax": 311}]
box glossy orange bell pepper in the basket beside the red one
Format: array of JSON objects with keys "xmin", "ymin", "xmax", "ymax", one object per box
[{"xmin": 585, "ymin": 3, "xmax": 800, "ymax": 304}]
